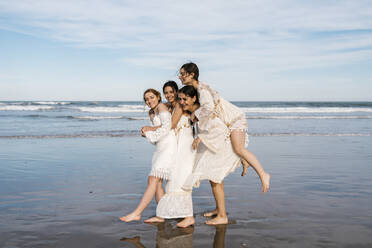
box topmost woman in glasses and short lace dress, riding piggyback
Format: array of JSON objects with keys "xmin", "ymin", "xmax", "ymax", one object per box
[{"xmin": 179, "ymin": 63, "xmax": 270, "ymax": 224}]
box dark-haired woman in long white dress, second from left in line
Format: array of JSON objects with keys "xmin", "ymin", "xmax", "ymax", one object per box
[{"xmin": 145, "ymin": 81, "xmax": 196, "ymax": 228}]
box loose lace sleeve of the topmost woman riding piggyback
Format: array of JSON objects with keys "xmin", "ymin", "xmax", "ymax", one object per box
[{"xmin": 195, "ymin": 88, "xmax": 215, "ymax": 130}]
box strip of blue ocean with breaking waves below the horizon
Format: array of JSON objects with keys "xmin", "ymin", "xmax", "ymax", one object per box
[{"xmin": 0, "ymin": 101, "xmax": 372, "ymax": 139}]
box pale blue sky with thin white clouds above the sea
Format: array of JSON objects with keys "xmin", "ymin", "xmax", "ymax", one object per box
[{"xmin": 0, "ymin": 0, "xmax": 372, "ymax": 101}]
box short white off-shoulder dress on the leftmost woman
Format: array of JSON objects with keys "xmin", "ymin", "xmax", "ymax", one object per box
[{"xmin": 146, "ymin": 111, "xmax": 177, "ymax": 180}]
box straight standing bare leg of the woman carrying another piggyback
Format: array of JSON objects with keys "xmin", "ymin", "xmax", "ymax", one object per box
[{"xmin": 205, "ymin": 181, "xmax": 228, "ymax": 225}]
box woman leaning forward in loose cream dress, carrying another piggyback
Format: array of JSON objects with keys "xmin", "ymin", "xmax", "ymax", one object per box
[{"xmin": 178, "ymin": 86, "xmax": 240, "ymax": 224}]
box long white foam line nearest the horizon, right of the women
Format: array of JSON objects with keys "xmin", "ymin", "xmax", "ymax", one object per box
[{"xmin": 241, "ymin": 107, "xmax": 372, "ymax": 113}]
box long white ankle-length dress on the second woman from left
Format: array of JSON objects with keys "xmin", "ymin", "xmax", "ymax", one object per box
[{"xmin": 156, "ymin": 115, "xmax": 196, "ymax": 219}]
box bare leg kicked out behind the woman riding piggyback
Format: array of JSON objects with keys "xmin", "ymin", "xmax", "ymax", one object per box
[{"xmin": 230, "ymin": 130, "xmax": 270, "ymax": 194}]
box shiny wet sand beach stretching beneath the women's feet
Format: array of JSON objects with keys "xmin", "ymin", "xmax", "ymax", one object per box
[{"xmin": 0, "ymin": 136, "xmax": 372, "ymax": 248}]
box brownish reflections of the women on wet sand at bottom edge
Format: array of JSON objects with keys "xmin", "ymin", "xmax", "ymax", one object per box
[{"xmin": 120, "ymin": 222, "xmax": 227, "ymax": 248}]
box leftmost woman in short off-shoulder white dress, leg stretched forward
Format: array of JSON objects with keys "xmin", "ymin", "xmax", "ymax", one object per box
[{"xmin": 120, "ymin": 89, "xmax": 177, "ymax": 222}]
